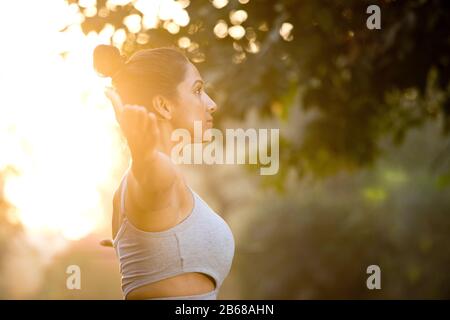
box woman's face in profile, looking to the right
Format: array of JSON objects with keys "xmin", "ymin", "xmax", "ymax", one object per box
[{"xmin": 171, "ymin": 62, "xmax": 217, "ymax": 140}]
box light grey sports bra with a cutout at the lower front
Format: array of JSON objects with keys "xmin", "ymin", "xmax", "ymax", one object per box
[{"xmin": 113, "ymin": 170, "xmax": 235, "ymax": 299}]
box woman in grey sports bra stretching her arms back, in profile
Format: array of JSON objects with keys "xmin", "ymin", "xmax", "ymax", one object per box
[{"xmin": 94, "ymin": 45, "xmax": 234, "ymax": 300}]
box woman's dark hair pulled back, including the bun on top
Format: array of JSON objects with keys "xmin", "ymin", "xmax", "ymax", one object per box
[{"xmin": 94, "ymin": 45, "xmax": 189, "ymax": 109}]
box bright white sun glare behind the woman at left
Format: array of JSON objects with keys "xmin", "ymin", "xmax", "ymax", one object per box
[{"xmin": 0, "ymin": 0, "xmax": 126, "ymax": 239}]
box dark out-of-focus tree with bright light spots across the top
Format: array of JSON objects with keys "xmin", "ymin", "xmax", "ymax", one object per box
[{"xmin": 69, "ymin": 0, "xmax": 450, "ymax": 177}]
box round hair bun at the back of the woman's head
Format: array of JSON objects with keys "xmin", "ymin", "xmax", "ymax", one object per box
[{"xmin": 94, "ymin": 44, "xmax": 125, "ymax": 77}]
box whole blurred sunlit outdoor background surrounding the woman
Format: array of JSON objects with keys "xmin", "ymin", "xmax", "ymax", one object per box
[{"xmin": 0, "ymin": 0, "xmax": 450, "ymax": 299}]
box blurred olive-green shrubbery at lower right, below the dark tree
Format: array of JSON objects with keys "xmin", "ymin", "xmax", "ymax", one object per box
[{"xmin": 234, "ymin": 119, "xmax": 450, "ymax": 299}]
